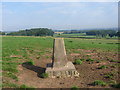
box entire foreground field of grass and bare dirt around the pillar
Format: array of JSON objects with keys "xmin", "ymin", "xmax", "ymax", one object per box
[{"xmin": 2, "ymin": 36, "xmax": 120, "ymax": 88}]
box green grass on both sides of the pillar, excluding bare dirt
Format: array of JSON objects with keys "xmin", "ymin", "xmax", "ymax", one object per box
[{"xmin": 2, "ymin": 36, "xmax": 119, "ymax": 87}]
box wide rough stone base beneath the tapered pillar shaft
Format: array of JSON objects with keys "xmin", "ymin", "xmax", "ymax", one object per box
[{"xmin": 46, "ymin": 62, "xmax": 79, "ymax": 78}]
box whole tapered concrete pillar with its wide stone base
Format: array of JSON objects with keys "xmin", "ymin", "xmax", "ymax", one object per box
[{"xmin": 45, "ymin": 38, "xmax": 79, "ymax": 78}]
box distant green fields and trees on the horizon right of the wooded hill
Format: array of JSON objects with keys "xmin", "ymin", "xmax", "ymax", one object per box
[{"xmin": 54, "ymin": 29, "xmax": 120, "ymax": 39}]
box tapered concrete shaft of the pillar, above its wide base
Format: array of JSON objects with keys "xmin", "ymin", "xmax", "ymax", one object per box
[{"xmin": 53, "ymin": 38, "xmax": 68, "ymax": 68}]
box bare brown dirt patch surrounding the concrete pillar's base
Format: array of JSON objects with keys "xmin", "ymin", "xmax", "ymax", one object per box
[{"xmin": 16, "ymin": 49, "xmax": 118, "ymax": 88}]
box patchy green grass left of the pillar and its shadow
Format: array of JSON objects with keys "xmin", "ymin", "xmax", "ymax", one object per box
[{"xmin": 2, "ymin": 36, "xmax": 53, "ymax": 87}]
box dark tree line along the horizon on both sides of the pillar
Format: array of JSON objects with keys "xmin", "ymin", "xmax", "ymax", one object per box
[{"xmin": 0, "ymin": 28, "xmax": 120, "ymax": 37}]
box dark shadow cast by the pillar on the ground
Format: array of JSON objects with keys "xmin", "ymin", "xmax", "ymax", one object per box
[{"xmin": 22, "ymin": 62, "xmax": 45, "ymax": 78}]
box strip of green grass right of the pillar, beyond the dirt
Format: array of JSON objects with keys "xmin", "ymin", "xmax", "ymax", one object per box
[{"xmin": 65, "ymin": 38, "xmax": 118, "ymax": 52}]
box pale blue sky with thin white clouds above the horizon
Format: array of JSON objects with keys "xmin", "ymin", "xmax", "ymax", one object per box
[{"xmin": 0, "ymin": 2, "xmax": 118, "ymax": 31}]
